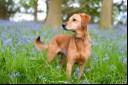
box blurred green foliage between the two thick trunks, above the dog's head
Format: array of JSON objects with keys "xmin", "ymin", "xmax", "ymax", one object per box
[{"xmin": 62, "ymin": 0, "xmax": 101, "ymax": 23}]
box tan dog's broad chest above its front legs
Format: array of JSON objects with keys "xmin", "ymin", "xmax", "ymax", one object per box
[{"xmin": 68, "ymin": 38, "xmax": 90, "ymax": 60}]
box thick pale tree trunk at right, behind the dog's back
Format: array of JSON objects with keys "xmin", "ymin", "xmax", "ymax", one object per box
[{"xmin": 100, "ymin": 0, "xmax": 113, "ymax": 29}]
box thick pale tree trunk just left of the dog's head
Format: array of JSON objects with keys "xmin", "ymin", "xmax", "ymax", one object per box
[{"xmin": 45, "ymin": 0, "xmax": 62, "ymax": 28}]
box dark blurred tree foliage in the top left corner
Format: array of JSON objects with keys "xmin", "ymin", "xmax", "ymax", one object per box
[{"xmin": 0, "ymin": 0, "xmax": 19, "ymax": 20}]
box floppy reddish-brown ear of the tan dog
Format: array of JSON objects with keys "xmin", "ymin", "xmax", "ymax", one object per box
[{"xmin": 80, "ymin": 13, "xmax": 91, "ymax": 27}]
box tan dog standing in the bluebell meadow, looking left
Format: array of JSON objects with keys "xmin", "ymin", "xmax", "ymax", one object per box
[{"xmin": 35, "ymin": 13, "xmax": 91, "ymax": 79}]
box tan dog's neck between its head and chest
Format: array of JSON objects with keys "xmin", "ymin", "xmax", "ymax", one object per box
[{"xmin": 75, "ymin": 28, "xmax": 88, "ymax": 40}]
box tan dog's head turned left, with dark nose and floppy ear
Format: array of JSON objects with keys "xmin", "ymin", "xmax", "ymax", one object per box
[{"xmin": 62, "ymin": 13, "xmax": 91, "ymax": 31}]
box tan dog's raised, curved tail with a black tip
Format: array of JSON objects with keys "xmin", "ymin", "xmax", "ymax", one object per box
[{"xmin": 34, "ymin": 36, "xmax": 48, "ymax": 51}]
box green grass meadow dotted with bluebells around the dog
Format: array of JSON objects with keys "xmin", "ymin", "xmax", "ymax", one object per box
[{"xmin": 0, "ymin": 21, "xmax": 127, "ymax": 84}]
